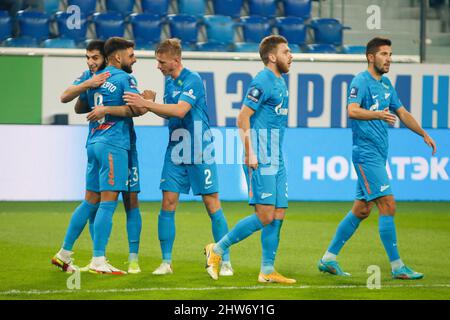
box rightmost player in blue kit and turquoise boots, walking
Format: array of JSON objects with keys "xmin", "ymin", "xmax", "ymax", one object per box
[{"xmin": 318, "ymin": 37, "xmax": 436, "ymax": 279}]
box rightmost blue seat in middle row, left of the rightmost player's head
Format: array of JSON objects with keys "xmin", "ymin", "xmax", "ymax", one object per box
[{"xmin": 309, "ymin": 18, "xmax": 350, "ymax": 46}]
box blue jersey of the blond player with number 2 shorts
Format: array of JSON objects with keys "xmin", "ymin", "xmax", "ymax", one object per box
[{"xmin": 164, "ymin": 68, "xmax": 214, "ymax": 164}]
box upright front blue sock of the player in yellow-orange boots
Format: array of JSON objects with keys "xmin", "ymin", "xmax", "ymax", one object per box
[{"xmin": 261, "ymin": 220, "xmax": 283, "ymax": 274}]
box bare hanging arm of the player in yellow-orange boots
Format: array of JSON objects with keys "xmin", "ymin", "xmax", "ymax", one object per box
[{"xmin": 237, "ymin": 104, "xmax": 258, "ymax": 169}]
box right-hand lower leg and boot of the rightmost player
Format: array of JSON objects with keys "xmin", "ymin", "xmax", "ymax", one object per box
[{"xmin": 374, "ymin": 195, "xmax": 423, "ymax": 280}]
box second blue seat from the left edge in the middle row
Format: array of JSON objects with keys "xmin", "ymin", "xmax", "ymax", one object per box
[{"xmin": 16, "ymin": 10, "xmax": 50, "ymax": 41}]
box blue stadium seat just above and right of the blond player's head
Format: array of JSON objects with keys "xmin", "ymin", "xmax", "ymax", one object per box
[{"xmin": 168, "ymin": 14, "xmax": 198, "ymax": 44}]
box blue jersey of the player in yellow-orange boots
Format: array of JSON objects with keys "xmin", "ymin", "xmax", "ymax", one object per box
[{"xmin": 243, "ymin": 68, "xmax": 289, "ymax": 164}]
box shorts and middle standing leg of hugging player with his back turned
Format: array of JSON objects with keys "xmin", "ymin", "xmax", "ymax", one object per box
[{"xmin": 89, "ymin": 143, "xmax": 128, "ymax": 274}]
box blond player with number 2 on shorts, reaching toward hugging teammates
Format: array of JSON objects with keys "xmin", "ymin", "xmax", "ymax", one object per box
[{"xmin": 124, "ymin": 39, "xmax": 233, "ymax": 276}]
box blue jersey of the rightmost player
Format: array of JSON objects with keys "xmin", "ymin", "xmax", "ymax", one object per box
[{"xmin": 347, "ymin": 70, "xmax": 402, "ymax": 162}]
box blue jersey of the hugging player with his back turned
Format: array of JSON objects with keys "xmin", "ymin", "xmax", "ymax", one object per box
[{"xmin": 87, "ymin": 66, "xmax": 139, "ymax": 150}]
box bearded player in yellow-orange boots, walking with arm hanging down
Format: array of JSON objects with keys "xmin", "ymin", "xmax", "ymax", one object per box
[{"xmin": 205, "ymin": 35, "xmax": 296, "ymax": 283}]
